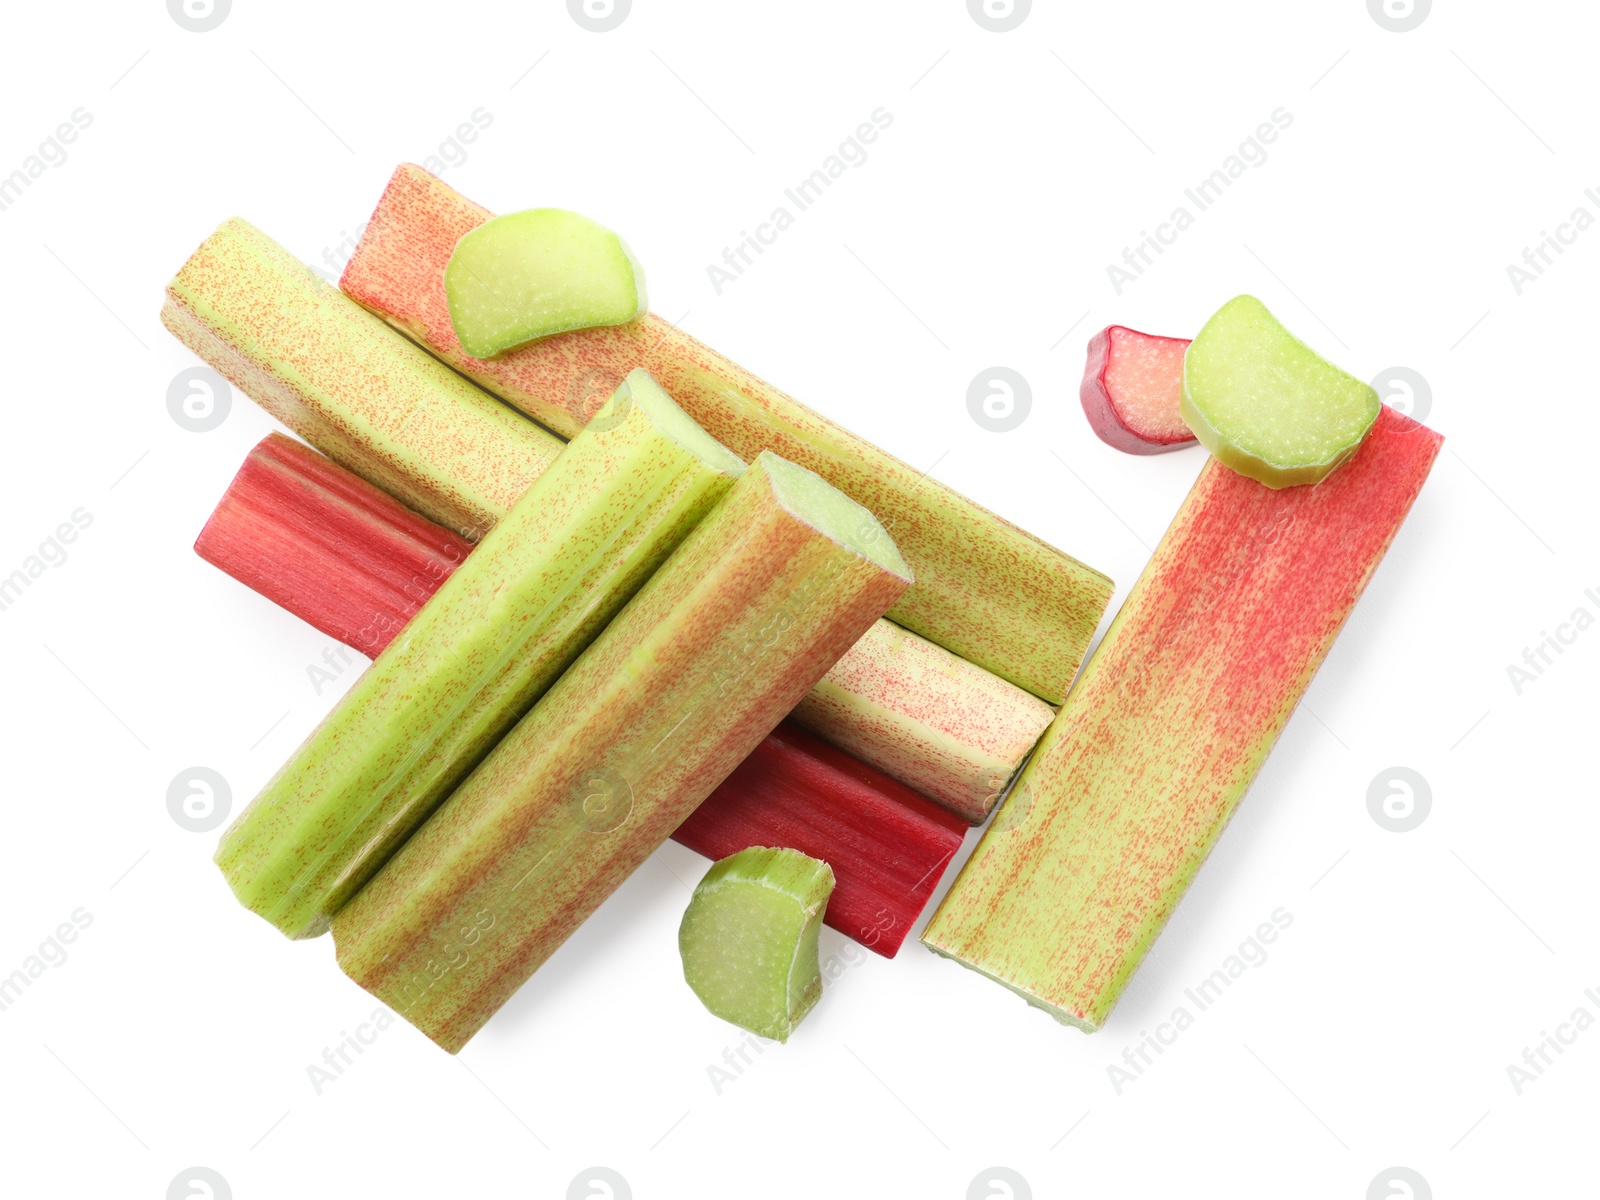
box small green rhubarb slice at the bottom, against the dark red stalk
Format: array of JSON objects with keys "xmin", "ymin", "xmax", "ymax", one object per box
[{"xmin": 678, "ymin": 846, "xmax": 834, "ymax": 1042}]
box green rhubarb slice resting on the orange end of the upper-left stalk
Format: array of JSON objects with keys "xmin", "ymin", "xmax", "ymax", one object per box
[{"xmin": 445, "ymin": 208, "xmax": 650, "ymax": 358}]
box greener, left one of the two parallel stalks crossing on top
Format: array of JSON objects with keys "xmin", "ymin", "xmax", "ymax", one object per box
[{"xmin": 216, "ymin": 370, "xmax": 744, "ymax": 938}]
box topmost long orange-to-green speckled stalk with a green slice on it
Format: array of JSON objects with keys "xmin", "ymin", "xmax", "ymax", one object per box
[{"xmin": 341, "ymin": 165, "xmax": 1112, "ymax": 704}]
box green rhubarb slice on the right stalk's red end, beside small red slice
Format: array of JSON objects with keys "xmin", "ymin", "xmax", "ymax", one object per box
[{"xmin": 1181, "ymin": 296, "xmax": 1379, "ymax": 488}]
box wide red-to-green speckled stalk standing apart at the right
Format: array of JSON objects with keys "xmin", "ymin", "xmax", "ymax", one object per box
[{"xmin": 922, "ymin": 408, "xmax": 1443, "ymax": 1032}]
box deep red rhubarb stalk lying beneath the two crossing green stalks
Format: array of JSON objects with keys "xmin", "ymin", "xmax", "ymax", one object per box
[{"xmin": 188, "ymin": 448, "xmax": 960, "ymax": 957}]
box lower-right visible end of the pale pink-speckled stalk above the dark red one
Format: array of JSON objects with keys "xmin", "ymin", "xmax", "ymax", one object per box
[{"xmin": 792, "ymin": 621, "xmax": 1056, "ymax": 826}]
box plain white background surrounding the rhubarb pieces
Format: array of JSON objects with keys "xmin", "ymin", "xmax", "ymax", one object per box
[{"xmin": 0, "ymin": 0, "xmax": 1600, "ymax": 1200}]
